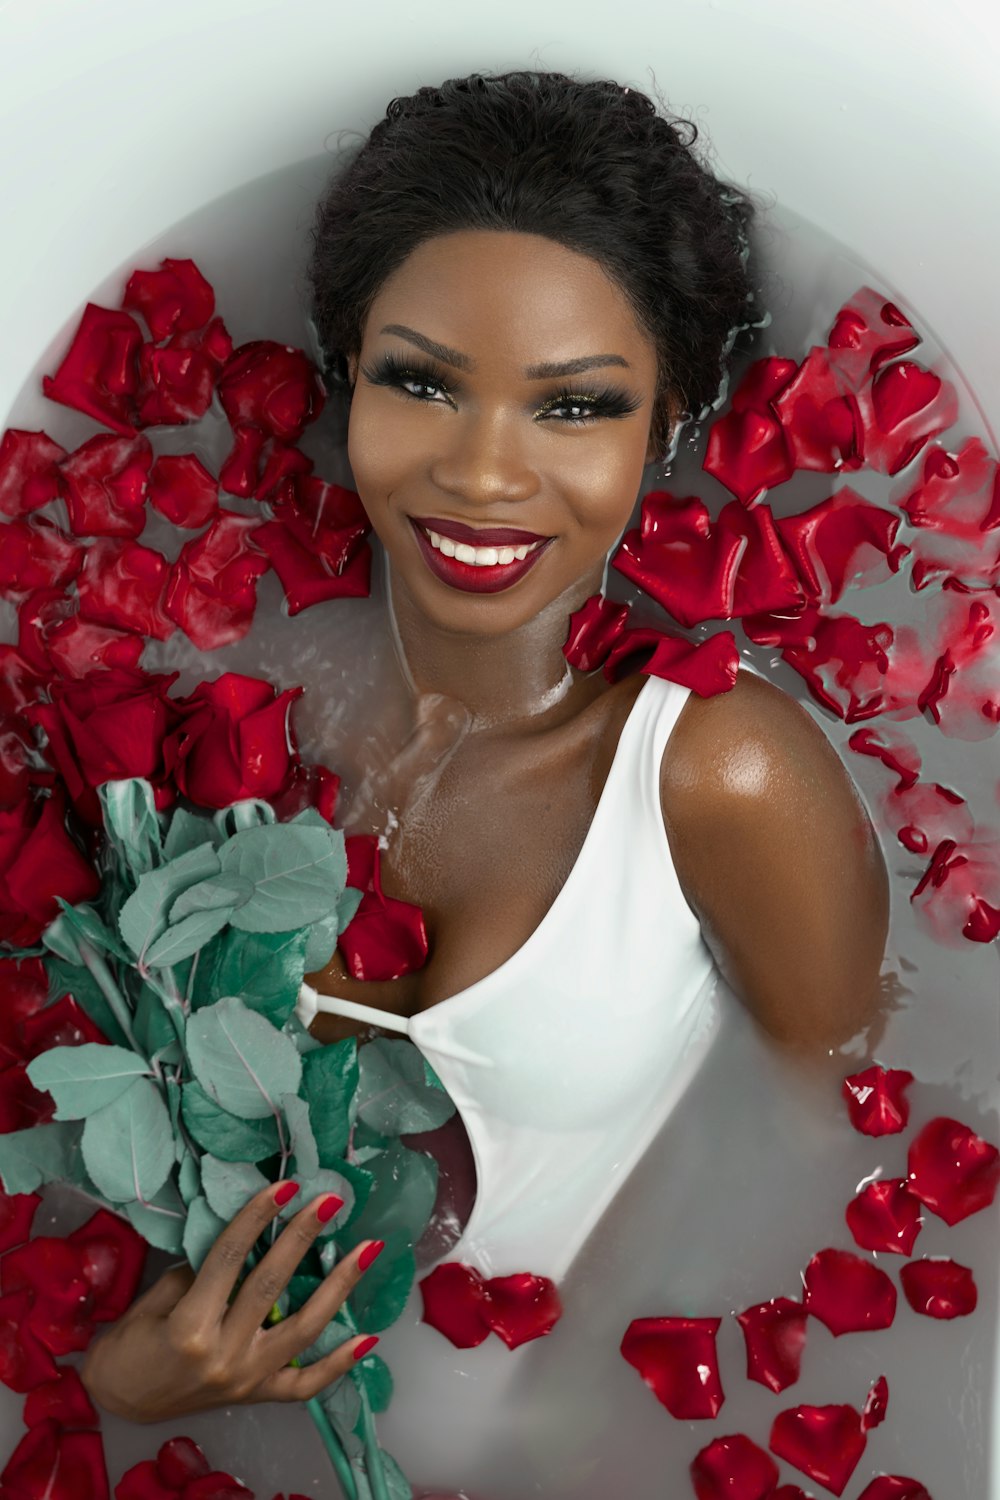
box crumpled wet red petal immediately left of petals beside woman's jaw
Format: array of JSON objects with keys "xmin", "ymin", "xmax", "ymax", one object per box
[{"xmin": 165, "ymin": 510, "xmax": 271, "ymax": 651}]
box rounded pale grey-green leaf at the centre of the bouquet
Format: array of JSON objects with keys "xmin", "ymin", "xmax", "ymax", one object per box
[{"xmin": 186, "ymin": 995, "xmax": 301, "ymax": 1119}]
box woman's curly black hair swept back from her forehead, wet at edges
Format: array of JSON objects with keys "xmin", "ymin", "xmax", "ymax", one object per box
[{"xmin": 306, "ymin": 71, "xmax": 766, "ymax": 456}]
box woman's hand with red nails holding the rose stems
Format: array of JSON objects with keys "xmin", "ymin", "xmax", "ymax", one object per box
[{"xmin": 81, "ymin": 1184, "xmax": 381, "ymax": 1422}]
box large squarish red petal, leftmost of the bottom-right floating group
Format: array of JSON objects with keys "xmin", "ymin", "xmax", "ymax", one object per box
[{"xmin": 621, "ymin": 1317, "xmax": 726, "ymax": 1419}]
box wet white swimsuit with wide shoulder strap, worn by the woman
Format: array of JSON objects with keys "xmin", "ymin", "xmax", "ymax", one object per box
[{"xmin": 297, "ymin": 663, "xmax": 742, "ymax": 1281}]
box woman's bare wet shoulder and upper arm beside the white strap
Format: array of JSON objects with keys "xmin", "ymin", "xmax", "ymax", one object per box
[{"xmin": 661, "ymin": 672, "xmax": 889, "ymax": 1052}]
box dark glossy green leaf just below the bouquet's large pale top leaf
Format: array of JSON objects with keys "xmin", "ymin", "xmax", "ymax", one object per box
[{"xmin": 196, "ymin": 927, "xmax": 309, "ymax": 1028}]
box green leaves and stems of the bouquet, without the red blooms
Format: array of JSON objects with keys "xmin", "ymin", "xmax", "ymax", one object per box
[{"xmin": 0, "ymin": 777, "xmax": 453, "ymax": 1500}]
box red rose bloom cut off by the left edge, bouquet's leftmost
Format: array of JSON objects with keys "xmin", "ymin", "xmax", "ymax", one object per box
[{"xmin": 0, "ymin": 786, "xmax": 100, "ymax": 947}]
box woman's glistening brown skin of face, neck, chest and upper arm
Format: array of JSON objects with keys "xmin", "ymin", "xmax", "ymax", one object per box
[{"xmin": 307, "ymin": 230, "xmax": 889, "ymax": 1053}]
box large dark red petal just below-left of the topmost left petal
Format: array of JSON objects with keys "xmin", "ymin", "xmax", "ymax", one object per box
[{"xmin": 42, "ymin": 302, "xmax": 142, "ymax": 437}]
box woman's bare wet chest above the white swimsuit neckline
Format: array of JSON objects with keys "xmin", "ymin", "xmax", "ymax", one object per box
[{"xmin": 306, "ymin": 684, "xmax": 637, "ymax": 1043}]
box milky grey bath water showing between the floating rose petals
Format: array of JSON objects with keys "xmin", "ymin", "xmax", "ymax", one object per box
[{"xmin": 0, "ymin": 138, "xmax": 1000, "ymax": 1500}]
